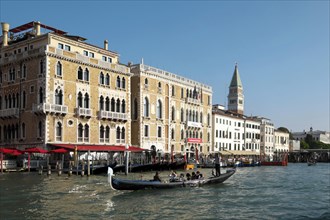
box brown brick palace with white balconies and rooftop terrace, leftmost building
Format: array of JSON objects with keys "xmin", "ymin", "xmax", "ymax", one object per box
[{"xmin": 0, "ymin": 22, "xmax": 132, "ymax": 150}]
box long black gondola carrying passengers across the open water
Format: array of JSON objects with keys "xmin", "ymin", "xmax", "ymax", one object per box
[{"xmin": 108, "ymin": 168, "xmax": 236, "ymax": 190}]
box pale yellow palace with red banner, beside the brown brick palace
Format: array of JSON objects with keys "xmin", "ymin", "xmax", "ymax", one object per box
[{"xmin": 131, "ymin": 63, "xmax": 212, "ymax": 156}]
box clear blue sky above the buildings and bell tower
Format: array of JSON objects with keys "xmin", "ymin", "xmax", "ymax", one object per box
[{"xmin": 0, "ymin": 0, "xmax": 330, "ymax": 131}]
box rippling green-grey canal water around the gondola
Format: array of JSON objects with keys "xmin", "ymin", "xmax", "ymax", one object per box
[{"xmin": 0, "ymin": 163, "xmax": 330, "ymax": 219}]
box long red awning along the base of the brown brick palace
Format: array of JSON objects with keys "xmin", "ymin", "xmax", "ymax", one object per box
[{"xmin": 50, "ymin": 144, "xmax": 146, "ymax": 152}]
